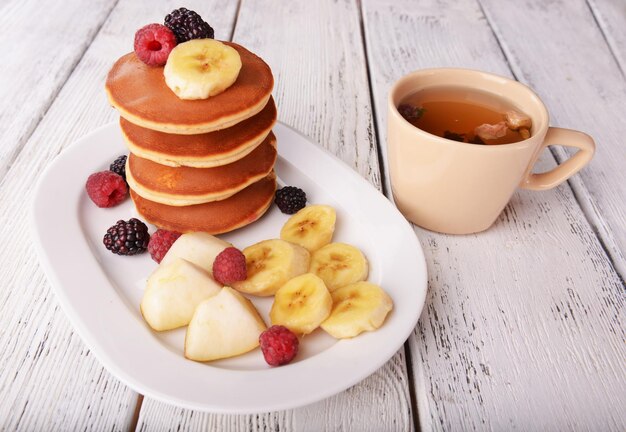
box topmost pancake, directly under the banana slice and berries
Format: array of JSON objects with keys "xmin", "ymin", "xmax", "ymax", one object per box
[{"xmin": 105, "ymin": 42, "xmax": 274, "ymax": 135}]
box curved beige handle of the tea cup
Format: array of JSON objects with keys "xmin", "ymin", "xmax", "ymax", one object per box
[{"xmin": 520, "ymin": 127, "xmax": 596, "ymax": 190}]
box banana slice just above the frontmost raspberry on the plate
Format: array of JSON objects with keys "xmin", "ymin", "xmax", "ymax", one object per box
[{"xmin": 270, "ymin": 273, "xmax": 333, "ymax": 334}]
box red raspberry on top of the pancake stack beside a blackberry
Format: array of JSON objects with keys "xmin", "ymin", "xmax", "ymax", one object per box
[{"xmin": 135, "ymin": 24, "xmax": 176, "ymax": 66}]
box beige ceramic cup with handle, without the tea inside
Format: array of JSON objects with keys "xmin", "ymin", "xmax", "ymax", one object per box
[{"xmin": 387, "ymin": 69, "xmax": 595, "ymax": 234}]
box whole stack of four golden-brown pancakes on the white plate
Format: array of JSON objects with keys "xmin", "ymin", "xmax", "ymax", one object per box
[{"xmin": 106, "ymin": 42, "xmax": 277, "ymax": 234}]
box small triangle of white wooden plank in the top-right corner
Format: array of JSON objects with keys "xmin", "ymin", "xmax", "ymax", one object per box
[{"xmin": 587, "ymin": 0, "xmax": 626, "ymax": 74}]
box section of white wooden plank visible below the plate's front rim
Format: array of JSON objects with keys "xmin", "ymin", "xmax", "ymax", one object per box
[{"xmin": 137, "ymin": 354, "xmax": 413, "ymax": 432}]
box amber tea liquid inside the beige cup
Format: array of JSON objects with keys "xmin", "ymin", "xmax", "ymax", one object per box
[{"xmin": 398, "ymin": 87, "xmax": 527, "ymax": 145}]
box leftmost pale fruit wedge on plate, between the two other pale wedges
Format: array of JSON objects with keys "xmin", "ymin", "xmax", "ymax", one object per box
[{"xmin": 140, "ymin": 258, "xmax": 222, "ymax": 331}]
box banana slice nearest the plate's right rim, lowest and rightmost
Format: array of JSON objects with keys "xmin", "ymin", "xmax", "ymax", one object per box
[{"xmin": 321, "ymin": 282, "xmax": 393, "ymax": 339}]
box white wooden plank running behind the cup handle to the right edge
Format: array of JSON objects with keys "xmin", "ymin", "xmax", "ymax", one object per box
[{"xmin": 481, "ymin": 0, "xmax": 626, "ymax": 279}]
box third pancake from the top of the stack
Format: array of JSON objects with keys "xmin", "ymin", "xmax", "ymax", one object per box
[{"xmin": 126, "ymin": 133, "xmax": 277, "ymax": 206}]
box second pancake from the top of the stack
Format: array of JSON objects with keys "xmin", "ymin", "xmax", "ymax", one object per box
[{"xmin": 120, "ymin": 98, "xmax": 276, "ymax": 168}]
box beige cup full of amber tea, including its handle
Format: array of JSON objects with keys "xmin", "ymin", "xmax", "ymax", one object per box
[{"xmin": 387, "ymin": 68, "xmax": 595, "ymax": 234}]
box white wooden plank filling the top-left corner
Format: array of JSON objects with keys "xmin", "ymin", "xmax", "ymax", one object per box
[{"xmin": 0, "ymin": 0, "xmax": 115, "ymax": 180}]
